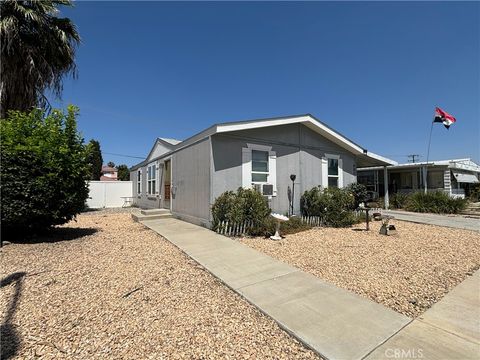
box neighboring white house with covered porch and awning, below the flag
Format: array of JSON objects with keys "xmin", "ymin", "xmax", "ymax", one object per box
[{"xmin": 357, "ymin": 159, "xmax": 480, "ymax": 198}]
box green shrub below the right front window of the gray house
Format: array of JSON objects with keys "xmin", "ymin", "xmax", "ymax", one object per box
[{"xmin": 300, "ymin": 187, "xmax": 355, "ymax": 227}]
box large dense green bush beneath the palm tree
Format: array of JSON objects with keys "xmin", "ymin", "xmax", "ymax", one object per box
[{"xmin": 0, "ymin": 106, "xmax": 89, "ymax": 235}]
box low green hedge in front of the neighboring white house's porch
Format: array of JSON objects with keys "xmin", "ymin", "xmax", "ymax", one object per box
[{"xmin": 405, "ymin": 191, "xmax": 467, "ymax": 214}]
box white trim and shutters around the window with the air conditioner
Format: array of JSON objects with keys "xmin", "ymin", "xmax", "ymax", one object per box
[{"xmin": 242, "ymin": 143, "xmax": 277, "ymax": 196}]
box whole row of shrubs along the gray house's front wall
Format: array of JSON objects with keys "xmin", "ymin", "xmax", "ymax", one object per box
[{"xmin": 212, "ymin": 184, "xmax": 380, "ymax": 236}]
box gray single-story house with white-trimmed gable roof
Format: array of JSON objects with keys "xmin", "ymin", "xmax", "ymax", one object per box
[{"xmin": 130, "ymin": 115, "xmax": 396, "ymax": 226}]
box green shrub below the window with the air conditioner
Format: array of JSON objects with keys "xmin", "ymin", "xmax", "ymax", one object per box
[{"xmin": 212, "ymin": 188, "xmax": 270, "ymax": 235}]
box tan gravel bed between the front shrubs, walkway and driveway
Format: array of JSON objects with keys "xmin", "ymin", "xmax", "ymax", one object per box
[{"xmin": 240, "ymin": 220, "xmax": 480, "ymax": 317}]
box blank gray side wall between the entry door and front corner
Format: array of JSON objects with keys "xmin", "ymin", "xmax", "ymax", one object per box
[{"xmin": 172, "ymin": 138, "xmax": 210, "ymax": 225}]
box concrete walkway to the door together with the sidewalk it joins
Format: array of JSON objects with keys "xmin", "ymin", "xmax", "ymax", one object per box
[{"xmin": 142, "ymin": 218, "xmax": 480, "ymax": 360}]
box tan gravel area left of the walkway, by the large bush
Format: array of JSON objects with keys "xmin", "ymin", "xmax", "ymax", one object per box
[{"xmin": 0, "ymin": 211, "xmax": 318, "ymax": 359}]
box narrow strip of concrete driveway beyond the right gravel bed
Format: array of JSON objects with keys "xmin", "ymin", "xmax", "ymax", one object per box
[{"xmin": 382, "ymin": 210, "xmax": 480, "ymax": 231}]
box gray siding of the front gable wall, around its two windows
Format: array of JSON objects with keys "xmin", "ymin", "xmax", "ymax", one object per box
[{"xmin": 210, "ymin": 124, "xmax": 356, "ymax": 213}]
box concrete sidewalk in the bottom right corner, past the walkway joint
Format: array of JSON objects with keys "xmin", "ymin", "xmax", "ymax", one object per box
[{"xmin": 367, "ymin": 271, "xmax": 480, "ymax": 360}]
